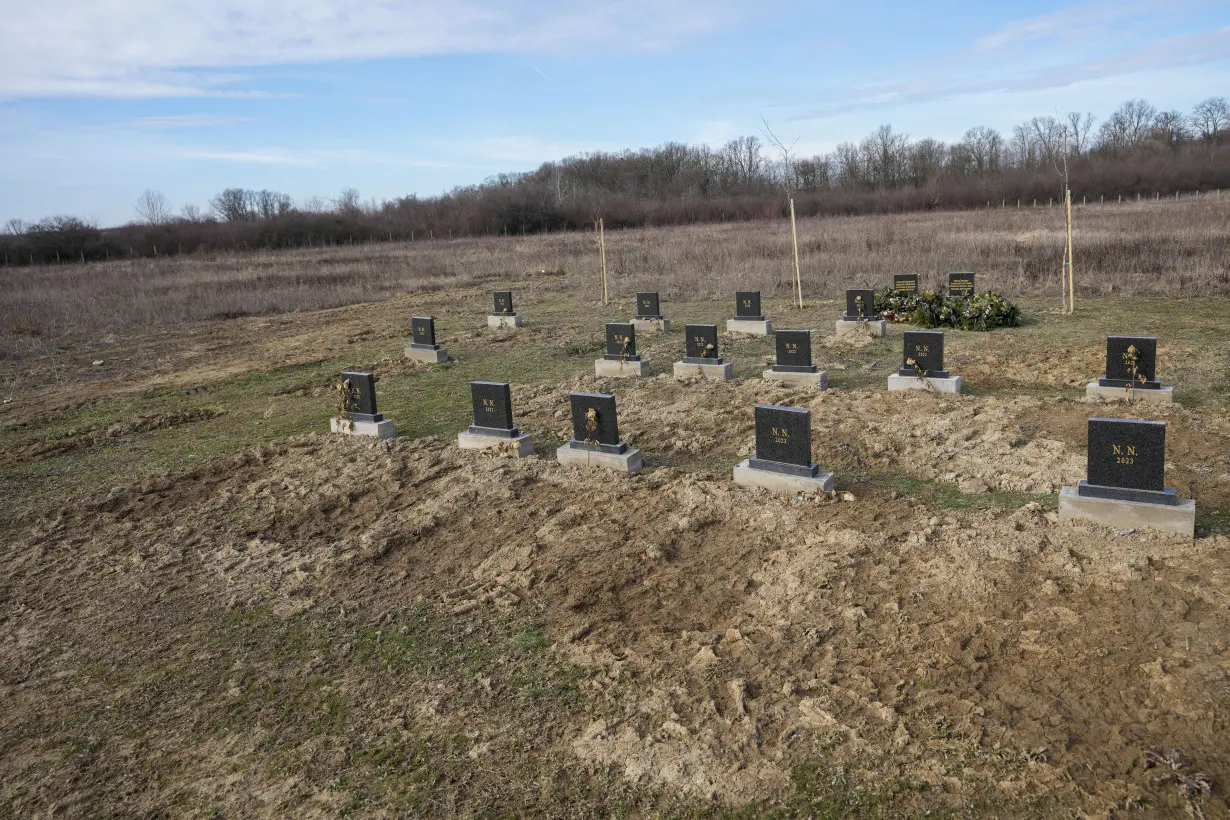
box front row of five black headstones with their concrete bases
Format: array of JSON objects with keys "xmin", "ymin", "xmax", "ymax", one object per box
[{"xmin": 333, "ymin": 371, "xmax": 1196, "ymax": 537}]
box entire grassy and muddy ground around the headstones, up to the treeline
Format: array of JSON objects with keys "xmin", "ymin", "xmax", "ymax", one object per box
[{"xmin": 0, "ymin": 198, "xmax": 1230, "ymax": 818}]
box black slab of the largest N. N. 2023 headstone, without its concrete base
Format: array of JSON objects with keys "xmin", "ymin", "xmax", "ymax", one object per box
[{"xmin": 1076, "ymin": 418, "xmax": 1178, "ymax": 505}]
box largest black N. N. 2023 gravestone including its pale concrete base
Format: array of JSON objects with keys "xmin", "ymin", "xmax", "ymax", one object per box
[{"xmin": 1059, "ymin": 418, "xmax": 1196, "ymax": 537}]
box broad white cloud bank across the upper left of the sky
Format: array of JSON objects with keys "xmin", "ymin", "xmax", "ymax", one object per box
[{"xmin": 0, "ymin": 0, "xmax": 736, "ymax": 98}]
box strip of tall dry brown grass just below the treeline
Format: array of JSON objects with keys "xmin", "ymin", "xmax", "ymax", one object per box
[{"xmin": 0, "ymin": 198, "xmax": 1230, "ymax": 361}]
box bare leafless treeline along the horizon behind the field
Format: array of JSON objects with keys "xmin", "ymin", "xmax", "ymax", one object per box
[{"xmin": 0, "ymin": 97, "xmax": 1230, "ymax": 264}]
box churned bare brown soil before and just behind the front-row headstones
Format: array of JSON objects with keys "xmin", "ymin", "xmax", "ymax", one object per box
[{"xmin": 0, "ymin": 427, "xmax": 1230, "ymax": 814}]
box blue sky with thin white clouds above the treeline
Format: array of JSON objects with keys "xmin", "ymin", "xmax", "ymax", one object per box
[{"xmin": 0, "ymin": 0, "xmax": 1230, "ymax": 225}]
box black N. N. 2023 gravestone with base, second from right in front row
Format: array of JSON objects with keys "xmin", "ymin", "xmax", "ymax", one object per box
[{"xmin": 734, "ymin": 404, "xmax": 834, "ymax": 493}]
